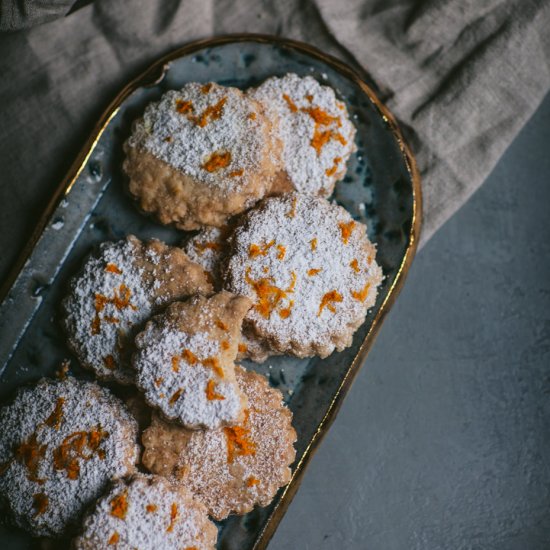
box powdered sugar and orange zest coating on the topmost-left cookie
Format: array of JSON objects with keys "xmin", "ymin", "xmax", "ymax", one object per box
[{"xmin": 128, "ymin": 82, "xmax": 266, "ymax": 192}]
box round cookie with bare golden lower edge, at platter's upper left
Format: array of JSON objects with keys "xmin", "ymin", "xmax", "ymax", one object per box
[{"xmin": 124, "ymin": 83, "xmax": 282, "ymax": 229}]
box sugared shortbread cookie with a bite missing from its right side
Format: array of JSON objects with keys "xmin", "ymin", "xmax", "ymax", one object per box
[{"xmin": 133, "ymin": 292, "xmax": 252, "ymax": 429}]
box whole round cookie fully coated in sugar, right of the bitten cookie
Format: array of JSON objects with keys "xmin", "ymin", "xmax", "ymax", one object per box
[{"xmin": 225, "ymin": 193, "xmax": 382, "ymax": 357}]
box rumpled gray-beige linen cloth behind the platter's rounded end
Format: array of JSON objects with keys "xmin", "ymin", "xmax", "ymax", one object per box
[{"xmin": 0, "ymin": 0, "xmax": 550, "ymax": 284}]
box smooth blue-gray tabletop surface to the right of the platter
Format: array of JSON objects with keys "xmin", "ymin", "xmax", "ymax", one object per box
[{"xmin": 270, "ymin": 95, "xmax": 550, "ymax": 550}]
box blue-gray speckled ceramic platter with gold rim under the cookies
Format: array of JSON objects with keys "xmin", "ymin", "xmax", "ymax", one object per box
[{"xmin": 0, "ymin": 35, "xmax": 421, "ymax": 550}]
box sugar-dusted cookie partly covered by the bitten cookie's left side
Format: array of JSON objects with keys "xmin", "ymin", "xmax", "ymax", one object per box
[{"xmin": 63, "ymin": 236, "xmax": 212, "ymax": 384}]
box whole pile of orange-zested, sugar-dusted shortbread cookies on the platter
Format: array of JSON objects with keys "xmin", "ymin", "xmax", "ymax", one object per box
[{"xmin": 0, "ymin": 75, "xmax": 382, "ymax": 550}]
